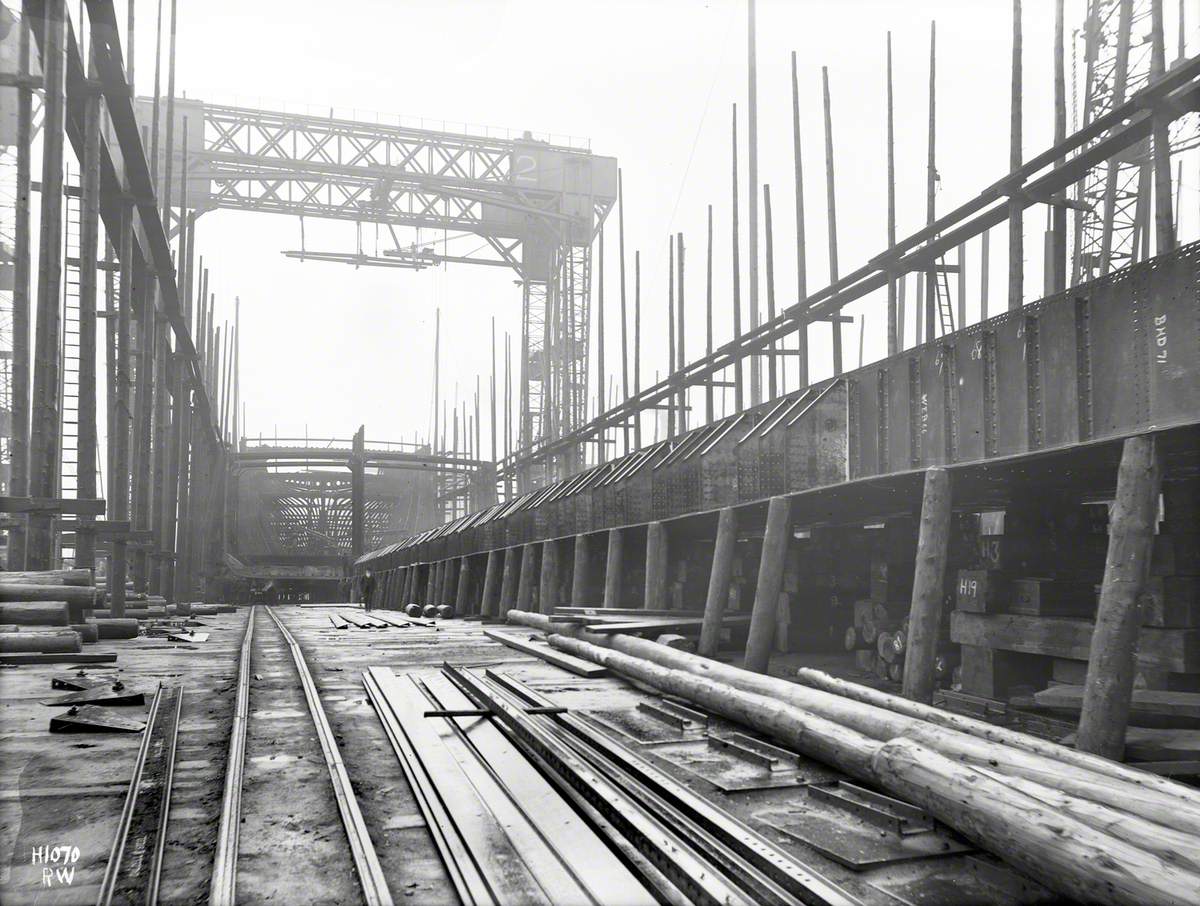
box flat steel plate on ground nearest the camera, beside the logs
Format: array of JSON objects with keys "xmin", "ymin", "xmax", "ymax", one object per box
[{"xmin": 755, "ymin": 798, "xmax": 974, "ymax": 871}]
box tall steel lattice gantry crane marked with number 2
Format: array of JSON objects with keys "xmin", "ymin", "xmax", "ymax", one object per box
[{"xmin": 169, "ymin": 101, "xmax": 617, "ymax": 485}]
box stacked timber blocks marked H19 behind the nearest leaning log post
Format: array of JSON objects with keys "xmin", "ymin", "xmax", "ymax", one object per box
[{"xmin": 948, "ymin": 487, "xmax": 1200, "ymax": 722}]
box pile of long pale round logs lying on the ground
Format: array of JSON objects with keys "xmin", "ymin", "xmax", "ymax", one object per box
[{"xmin": 509, "ymin": 611, "xmax": 1200, "ymax": 906}]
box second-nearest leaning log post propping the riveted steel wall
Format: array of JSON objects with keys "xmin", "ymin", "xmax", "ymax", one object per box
[{"xmin": 904, "ymin": 468, "xmax": 950, "ymax": 704}]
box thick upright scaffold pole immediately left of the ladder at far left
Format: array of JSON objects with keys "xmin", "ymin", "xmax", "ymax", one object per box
[{"xmin": 25, "ymin": 0, "xmax": 67, "ymax": 570}]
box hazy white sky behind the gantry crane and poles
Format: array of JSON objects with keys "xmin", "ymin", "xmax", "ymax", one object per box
[{"xmin": 110, "ymin": 0, "xmax": 1200, "ymax": 453}]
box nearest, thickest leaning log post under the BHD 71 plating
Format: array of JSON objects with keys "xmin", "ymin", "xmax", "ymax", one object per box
[{"xmin": 1076, "ymin": 434, "xmax": 1163, "ymax": 761}]
